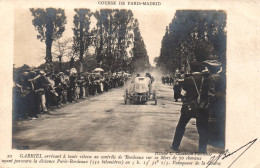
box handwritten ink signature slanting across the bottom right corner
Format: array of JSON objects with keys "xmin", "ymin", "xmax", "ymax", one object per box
[{"xmin": 206, "ymin": 138, "xmax": 257, "ymax": 168}]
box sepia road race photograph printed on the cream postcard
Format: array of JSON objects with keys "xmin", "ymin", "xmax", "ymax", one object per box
[{"xmin": 12, "ymin": 8, "xmax": 226, "ymax": 153}]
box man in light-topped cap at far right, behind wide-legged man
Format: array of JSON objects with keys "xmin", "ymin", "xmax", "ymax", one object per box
[{"xmin": 204, "ymin": 60, "xmax": 226, "ymax": 145}]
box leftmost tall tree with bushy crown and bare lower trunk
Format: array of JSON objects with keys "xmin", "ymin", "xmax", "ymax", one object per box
[{"xmin": 30, "ymin": 8, "xmax": 67, "ymax": 63}]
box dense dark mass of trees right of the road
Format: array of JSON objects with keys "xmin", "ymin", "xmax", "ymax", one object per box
[{"xmin": 157, "ymin": 10, "xmax": 226, "ymax": 72}]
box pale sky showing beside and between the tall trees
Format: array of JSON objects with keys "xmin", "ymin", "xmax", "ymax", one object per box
[{"xmin": 14, "ymin": 7, "xmax": 175, "ymax": 67}]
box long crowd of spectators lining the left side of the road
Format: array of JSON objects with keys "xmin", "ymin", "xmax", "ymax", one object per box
[{"xmin": 13, "ymin": 68, "xmax": 127, "ymax": 119}]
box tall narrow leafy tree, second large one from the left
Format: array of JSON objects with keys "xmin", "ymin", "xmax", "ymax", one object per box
[{"xmin": 72, "ymin": 9, "xmax": 92, "ymax": 72}]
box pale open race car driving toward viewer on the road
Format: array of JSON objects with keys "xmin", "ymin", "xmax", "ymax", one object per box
[{"xmin": 124, "ymin": 77, "xmax": 157, "ymax": 105}]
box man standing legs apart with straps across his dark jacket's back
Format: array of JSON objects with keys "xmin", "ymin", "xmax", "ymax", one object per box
[{"xmin": 171, "ymin": 62, "xmax": 209, "ymax": 153}]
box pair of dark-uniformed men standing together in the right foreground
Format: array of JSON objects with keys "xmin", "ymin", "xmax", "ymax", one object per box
[{"xmin": 171, "ymin": 60, "xmax": 226, "ymax": 153}]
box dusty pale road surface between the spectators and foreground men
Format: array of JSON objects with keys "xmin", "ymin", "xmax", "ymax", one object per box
[{"xmin": 13, "ymin": 84, "xmax": 223, "ymax": 152}]
